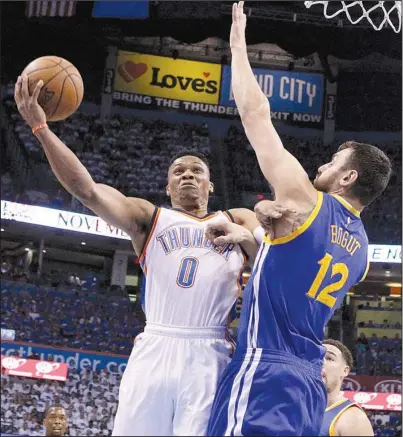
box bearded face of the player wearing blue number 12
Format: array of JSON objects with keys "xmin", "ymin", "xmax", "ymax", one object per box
[{"xmin": 313, "ymin": 149, "xmax": 357, "ymax": 193}]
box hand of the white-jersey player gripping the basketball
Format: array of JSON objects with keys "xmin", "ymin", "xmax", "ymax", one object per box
[{"xmin": 14, "ymin": 75, "xmax": 46, "ymax": 128}]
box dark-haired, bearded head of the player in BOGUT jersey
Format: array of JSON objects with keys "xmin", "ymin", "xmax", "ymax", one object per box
[{"xmin": 314, "ymin": 141, "xmax": 392, "ymax": 207}]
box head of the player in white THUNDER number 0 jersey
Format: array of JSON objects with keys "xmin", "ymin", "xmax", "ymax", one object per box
[{"xmin": 166, "ymin": 150, "xmax": 214, "ymax": 208}]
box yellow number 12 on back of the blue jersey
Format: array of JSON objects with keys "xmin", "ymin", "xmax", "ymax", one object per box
[{"xmin": 306, "ymin": 253, "xmax": 348, "ymax": 308}]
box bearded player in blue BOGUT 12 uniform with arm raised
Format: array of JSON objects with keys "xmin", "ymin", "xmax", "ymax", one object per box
[{"xmin": 208, "ymin": 2, "xmax": 391, "ymax": 436}]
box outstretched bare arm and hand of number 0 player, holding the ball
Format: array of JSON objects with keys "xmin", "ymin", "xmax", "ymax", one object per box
[{"xmin": 14, "ymin": 76, "xmax": 155, "ymax": 255}]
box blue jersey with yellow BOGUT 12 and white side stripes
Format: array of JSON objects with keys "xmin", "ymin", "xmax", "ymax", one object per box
[{"xmin": 237, "ymin": 192, "xmax": 368, "ymax": 366}]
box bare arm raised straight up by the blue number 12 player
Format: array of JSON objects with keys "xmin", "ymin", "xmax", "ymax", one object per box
[{"xmin": 230, "ymin": 1, "xmax": 317, "ymax": 211}]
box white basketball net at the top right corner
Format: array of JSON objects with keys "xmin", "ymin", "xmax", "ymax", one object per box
[{"xmin": 304, "ymin": 1, "xmax": 402, "ymax": 33}]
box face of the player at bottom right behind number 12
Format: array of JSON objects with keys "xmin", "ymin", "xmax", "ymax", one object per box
[{"xmin": 322, "ymin": 344, "xmax": 350, "ymax": 393}]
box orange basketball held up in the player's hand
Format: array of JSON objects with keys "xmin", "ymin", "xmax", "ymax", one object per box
[{"xmin": 22, "ymin": 56, "xmax": 84, "ymax": 121}]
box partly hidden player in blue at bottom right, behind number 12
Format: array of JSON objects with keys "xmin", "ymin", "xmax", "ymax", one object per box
[{"xmin": 319, "ymin": 339, "xmax": 374, "ymax": 436}]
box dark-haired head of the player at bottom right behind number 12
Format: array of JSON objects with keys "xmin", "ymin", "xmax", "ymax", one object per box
[{"xmin": 322, "ymin": 339, "xmax": 353, "ymax": 393}]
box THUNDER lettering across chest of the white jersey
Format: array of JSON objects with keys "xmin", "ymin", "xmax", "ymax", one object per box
[{"xmin": 156, "ymin": 227, "xmax": 235, "ymax": 261}]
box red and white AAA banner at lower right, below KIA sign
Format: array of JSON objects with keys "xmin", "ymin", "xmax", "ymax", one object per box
[{"xmin": 342, "ymin": 391, "xmax": 402, "ymax": 411}]
